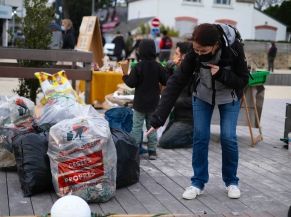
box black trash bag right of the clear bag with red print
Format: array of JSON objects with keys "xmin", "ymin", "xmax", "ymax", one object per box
[{"xmin": 110, "ymin": 128, "xmax": 140, "ymax": 188}]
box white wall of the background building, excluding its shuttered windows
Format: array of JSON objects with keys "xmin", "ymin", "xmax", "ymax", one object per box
[{"xmin": 128, "ymin": 0, "xmax": 286, "ymax": 40}]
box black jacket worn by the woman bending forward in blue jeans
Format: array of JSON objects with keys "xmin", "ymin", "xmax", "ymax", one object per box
[{"xmin": 151, "ymin": 41, "xmax": 249, "ymax": 128}]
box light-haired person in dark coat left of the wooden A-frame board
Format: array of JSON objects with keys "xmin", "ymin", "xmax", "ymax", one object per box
[{"xmin": 61, "ymin": 19, "xmax": 76, "ymax": 49}]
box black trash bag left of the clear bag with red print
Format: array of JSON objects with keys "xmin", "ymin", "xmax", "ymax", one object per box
[{"xmin": 13, "ymin": 133, "xmax": 52, "ymax": 197}]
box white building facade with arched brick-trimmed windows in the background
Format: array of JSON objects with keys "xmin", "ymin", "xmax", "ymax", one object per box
[{"xmin": 128, "ymin": 0, "xmax": 287, "ymax": 41}]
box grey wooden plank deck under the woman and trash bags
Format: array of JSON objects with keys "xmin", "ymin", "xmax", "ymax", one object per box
[{"xmin": 0, "ymin": 99, "xmax": 291, "ymax": 217}]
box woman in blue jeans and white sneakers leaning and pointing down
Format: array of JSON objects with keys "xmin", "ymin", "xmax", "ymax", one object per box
[{"xmin": 146, "ymin": 23, "xmax": 249, "ymax": 200}]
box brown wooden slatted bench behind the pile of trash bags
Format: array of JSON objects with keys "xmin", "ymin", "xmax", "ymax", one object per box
[{"xmin": 0, "ymin": 48, "xmax": 93, "ymax": 103}]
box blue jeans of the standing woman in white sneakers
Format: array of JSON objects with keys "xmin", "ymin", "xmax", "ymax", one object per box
[{"xmin": 191, "ymin": 97, "xmax": 240, "ymax": 189}]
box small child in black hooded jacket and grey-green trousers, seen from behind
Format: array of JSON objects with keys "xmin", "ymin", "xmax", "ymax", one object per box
[{"xmin": 122, "ymin": 39, "xmax": 166, "ymax": 160}]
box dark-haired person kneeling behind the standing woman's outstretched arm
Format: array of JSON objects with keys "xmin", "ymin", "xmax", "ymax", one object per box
[{"xmin": 159, "ymin": 42, "xmax": 193, "ymax": 148}]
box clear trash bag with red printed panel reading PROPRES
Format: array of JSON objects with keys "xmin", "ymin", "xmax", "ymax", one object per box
[{"xmin": 48, "ymin": 115, "xmax": 117, "ymax": 202}]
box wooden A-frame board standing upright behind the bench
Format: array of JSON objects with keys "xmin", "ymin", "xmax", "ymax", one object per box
[{"xmin": 75, "ymin": 16, "xmax": 103, "ymax": 67}]
